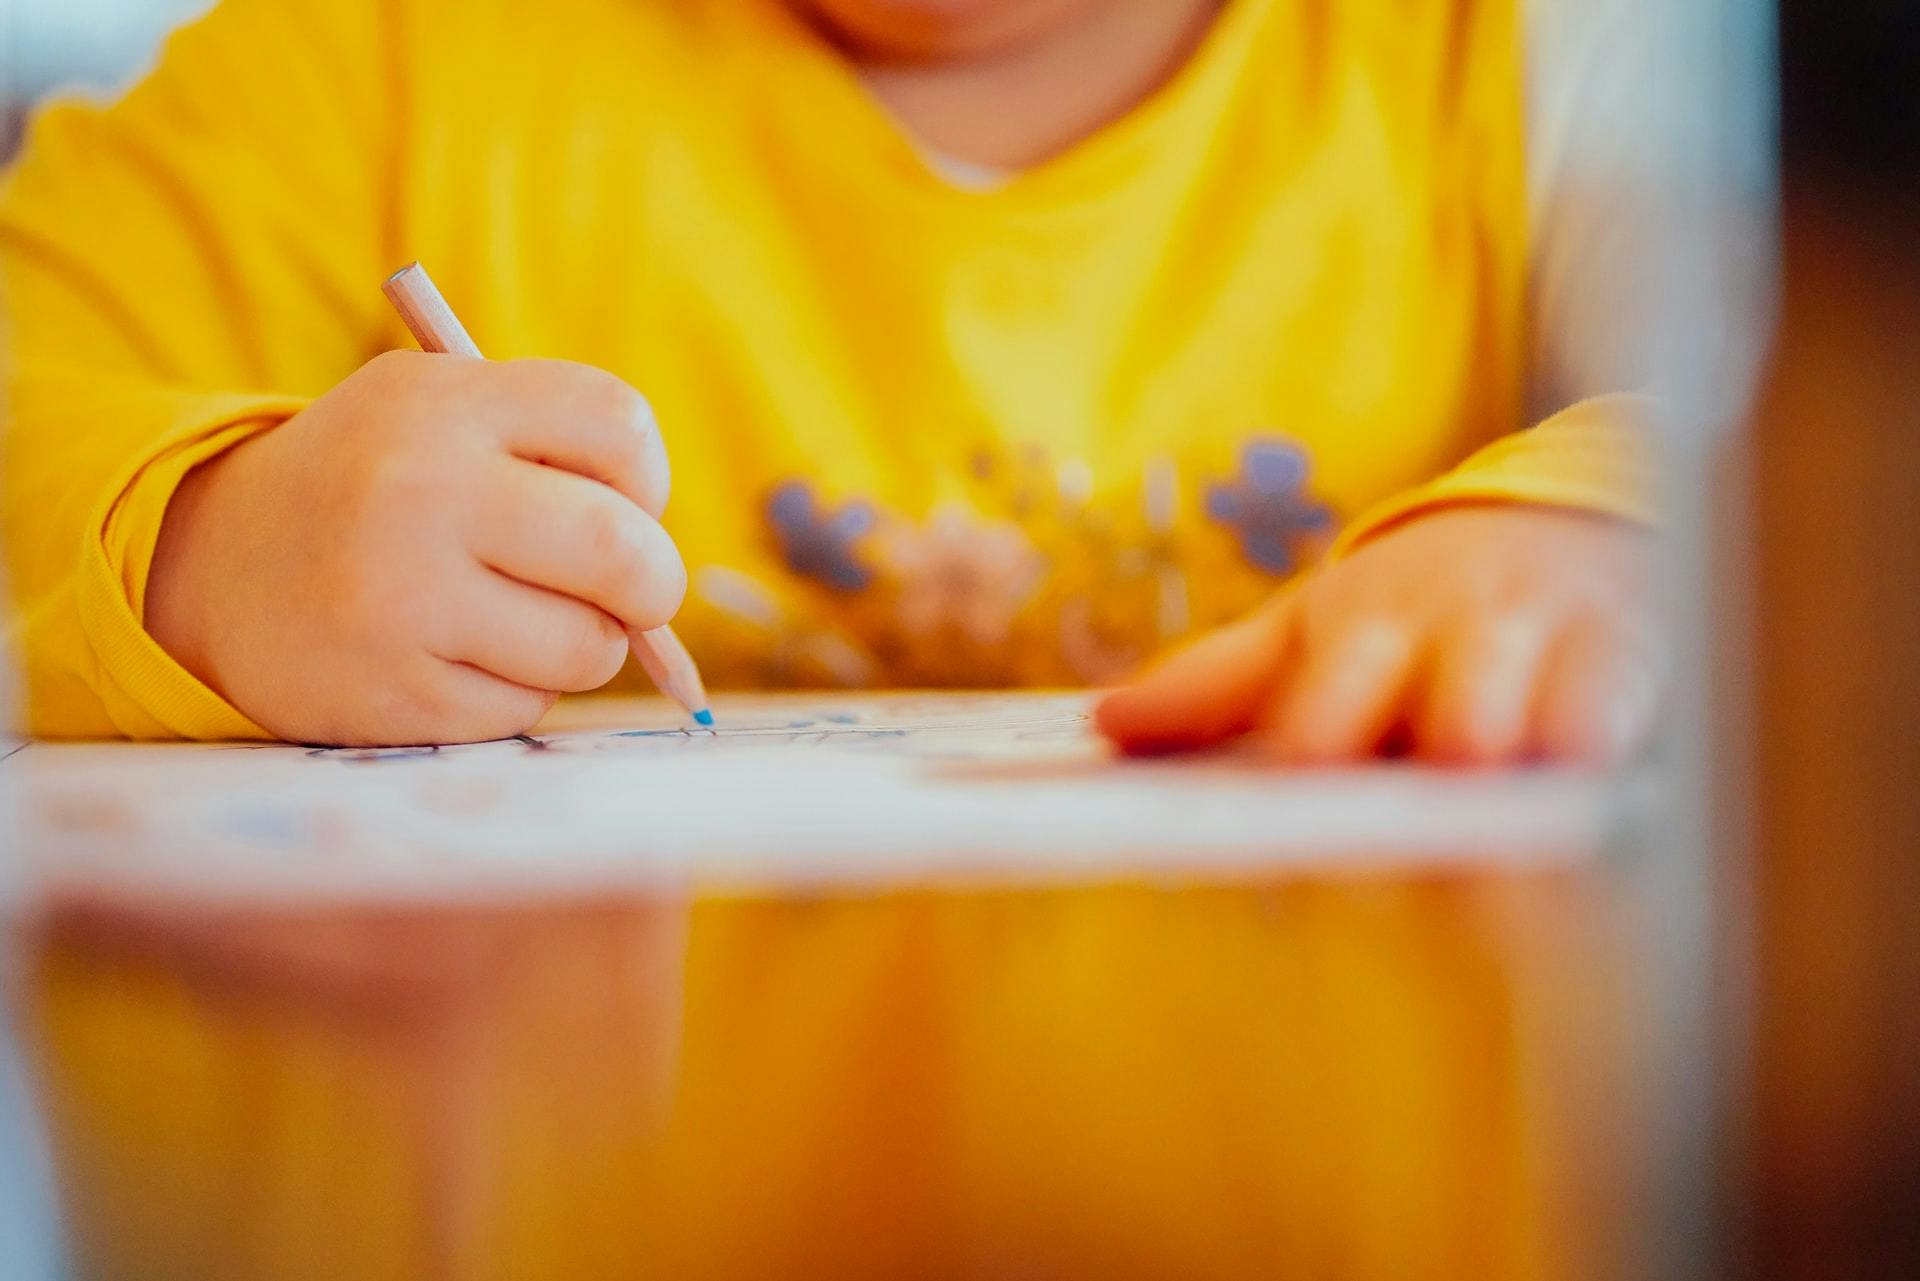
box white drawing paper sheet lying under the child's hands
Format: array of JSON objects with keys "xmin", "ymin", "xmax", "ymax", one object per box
[{"xmin": 0, "ymin": 693, "xmax": 1619, "ymax": 899}]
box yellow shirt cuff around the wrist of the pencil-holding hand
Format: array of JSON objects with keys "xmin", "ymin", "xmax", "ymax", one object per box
[{"xmin": 77, "ymin": 396, "xmax": 305, "ymax": 739}]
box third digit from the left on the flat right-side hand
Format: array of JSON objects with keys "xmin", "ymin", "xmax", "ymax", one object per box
[{"xmin": 1413, "ymin": 616, "xmax": 1551, "ymax": 764}]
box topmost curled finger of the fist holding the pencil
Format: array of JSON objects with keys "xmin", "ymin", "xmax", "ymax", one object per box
[{"xmin": 495, "ymin": 361, "xmax": 670, "ymax": 519}]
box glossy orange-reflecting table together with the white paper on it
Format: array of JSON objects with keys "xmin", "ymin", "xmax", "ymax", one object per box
[{"xmin": 10, "ymin": 695, "xmax": 1640, "ymax": 1279}]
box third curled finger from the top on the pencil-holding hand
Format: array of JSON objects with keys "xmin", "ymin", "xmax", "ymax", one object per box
[{"xmin": 434, "ymin": 567, "xmax": 626, "ymax": 693}]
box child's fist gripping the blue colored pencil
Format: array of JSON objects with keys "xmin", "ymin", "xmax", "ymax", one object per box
[{"xmin": 146, "ymin": 351, "xmax": 685, "ymax": 743}]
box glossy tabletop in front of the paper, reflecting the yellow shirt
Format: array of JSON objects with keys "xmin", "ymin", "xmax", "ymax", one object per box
[{"xmin": 22, "ymin": 870, "xmax": 1634, "ymax": 1281}]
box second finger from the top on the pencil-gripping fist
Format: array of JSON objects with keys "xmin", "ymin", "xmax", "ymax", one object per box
[{"xmin": 467, "ymin": 461, "xmax": 687, "ymax": 632}]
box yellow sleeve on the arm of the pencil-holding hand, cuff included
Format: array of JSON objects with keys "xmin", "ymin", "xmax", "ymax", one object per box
[{"xmin": 0, "ymin": 0, "xmax": 392, "ymax": 737}]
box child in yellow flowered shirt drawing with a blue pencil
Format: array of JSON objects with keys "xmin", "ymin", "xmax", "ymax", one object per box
[{"xmin": 0, "ymin": 0, "xmax": 1657, "ymax": 762}]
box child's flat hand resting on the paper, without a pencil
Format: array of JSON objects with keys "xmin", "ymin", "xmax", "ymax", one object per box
[{"xmin": 1098, "ymin": 505, "xmax": 1663, "ymax": 764}]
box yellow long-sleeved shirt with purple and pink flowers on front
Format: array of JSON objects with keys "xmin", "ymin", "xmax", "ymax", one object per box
[{"xmin": 0, "ymin": 0, "xmax": 1640, "ymax": 737}]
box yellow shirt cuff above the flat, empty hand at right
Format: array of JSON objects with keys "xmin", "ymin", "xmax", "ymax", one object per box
[{"xmin": 1327, "ymin": 394, "xmax": 1657, "ymax": 561}]
